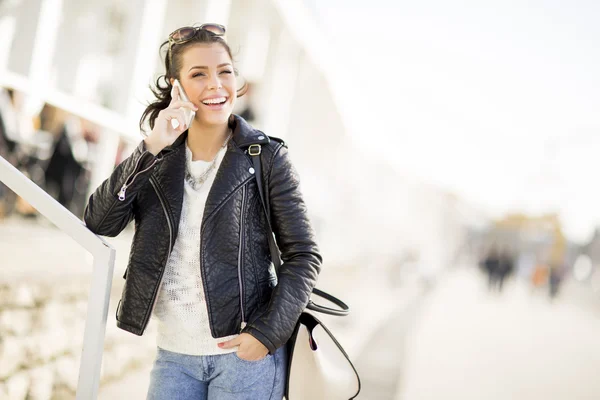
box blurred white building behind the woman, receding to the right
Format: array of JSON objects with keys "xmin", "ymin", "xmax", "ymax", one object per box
[{"xmin": 0, "ymin": 0, "xmax": 478, "ymax": 274}]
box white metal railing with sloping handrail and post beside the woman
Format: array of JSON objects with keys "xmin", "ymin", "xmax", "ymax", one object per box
[{"xmin": 0, "ymin": 157, "xmax": 115, "ymax": 400}]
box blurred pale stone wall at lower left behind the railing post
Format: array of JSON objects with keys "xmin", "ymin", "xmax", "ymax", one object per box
[{"xmin": 0, "ymin": 278, "xmax": 155, "ymax": 400}]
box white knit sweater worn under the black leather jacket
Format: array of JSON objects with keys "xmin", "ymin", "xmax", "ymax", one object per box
[{"xmin": 154, "ymin": 145, "xmax": 237, "ymax": 355}]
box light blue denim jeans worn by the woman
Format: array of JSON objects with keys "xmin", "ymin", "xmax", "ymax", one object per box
[{"xmin": 147, "ymin": 346, "xmax": 287, "ymax": 400}]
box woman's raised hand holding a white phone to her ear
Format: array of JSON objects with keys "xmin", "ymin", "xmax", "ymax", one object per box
[{"xmin": 144, "ymin": 86, "xmax": 198, "ymax": 155}]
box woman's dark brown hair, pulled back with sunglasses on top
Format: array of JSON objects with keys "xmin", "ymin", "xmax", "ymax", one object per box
[{"xmin": 140, "ymin": 29, "xmax": 247, "ymax": 132}]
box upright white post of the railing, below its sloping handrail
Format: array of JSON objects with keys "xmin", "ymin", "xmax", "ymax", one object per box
[{"xmin": 77, "ymin": 247, "xmax": 115, "ymax": 400}]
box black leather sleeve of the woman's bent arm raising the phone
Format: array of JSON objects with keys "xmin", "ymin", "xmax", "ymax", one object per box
[{"xmin": 83, "ymin": 141, "xmax": 160, "ymax": 236}]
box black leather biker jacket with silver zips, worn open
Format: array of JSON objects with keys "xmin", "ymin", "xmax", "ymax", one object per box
[{"xmin": 84, "ymin": 116, "xmax": 322, "ymax": 353}]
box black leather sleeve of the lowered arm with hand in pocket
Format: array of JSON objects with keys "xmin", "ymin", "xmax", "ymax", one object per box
[{"xmin": 243, "ymin": 146, "xmax": 322, "ymax": 353}]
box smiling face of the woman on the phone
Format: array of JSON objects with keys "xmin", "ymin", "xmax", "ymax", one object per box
[{"xmin": 179, "ymin": 43, "xmax": 237, "ymax": 125}]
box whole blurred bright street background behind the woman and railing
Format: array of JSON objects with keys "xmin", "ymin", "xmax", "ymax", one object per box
[{"xmin": 0, "ymin": 0, "xmax": 600, "ymax": 400}]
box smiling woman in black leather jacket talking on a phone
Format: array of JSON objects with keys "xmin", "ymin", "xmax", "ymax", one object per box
[{"xmin": 85, "ymin": 24, "xmax": 321, "ymax": 400}]
